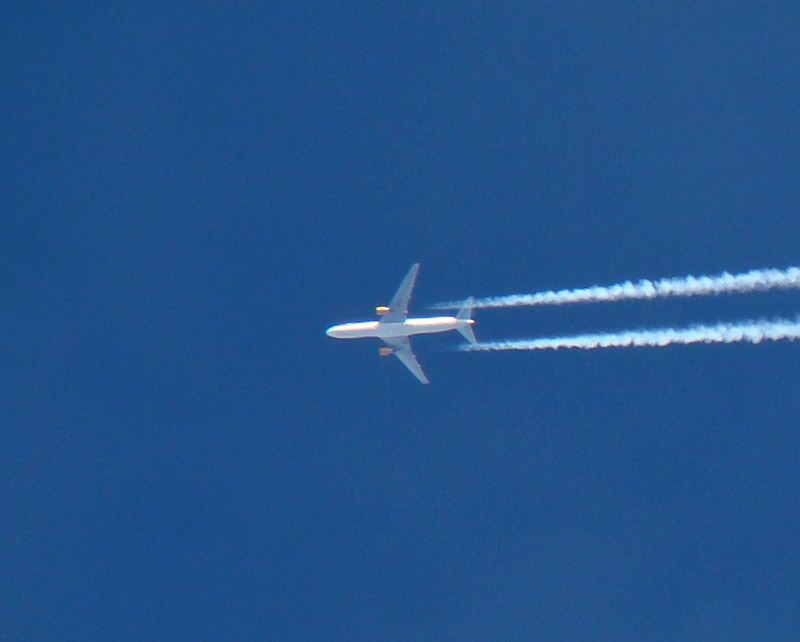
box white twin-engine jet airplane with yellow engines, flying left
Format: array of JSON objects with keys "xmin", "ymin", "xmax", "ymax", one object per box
[{"xmin": 325, "ymin": 263, "xmax": 477, "ymax": 383}]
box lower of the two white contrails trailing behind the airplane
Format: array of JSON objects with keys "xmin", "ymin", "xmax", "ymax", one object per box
[{"xmin": 459, "ymin": 318, "xmax": 800, "ymax": 352}]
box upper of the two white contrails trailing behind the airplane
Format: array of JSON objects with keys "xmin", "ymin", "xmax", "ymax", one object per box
[{"xmin": 432, "ymin": 267, "xmax": 800, "ymax": 310}]
